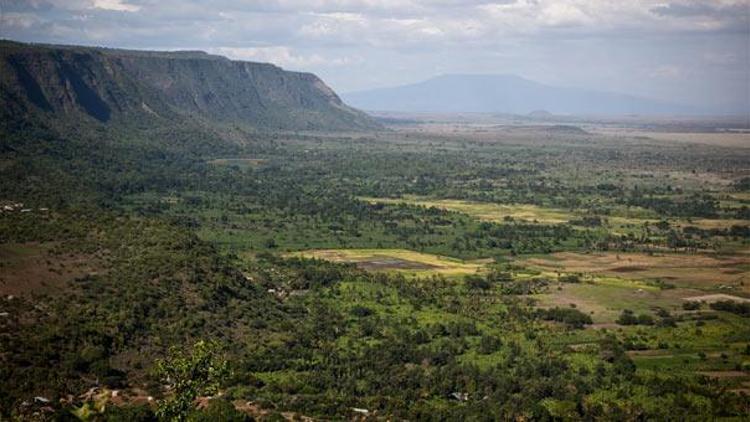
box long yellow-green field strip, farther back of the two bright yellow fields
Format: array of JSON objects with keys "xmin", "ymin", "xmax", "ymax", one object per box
[{"xmin": 360, "ymin": 195, "xmax": 576, "ymax": 224}]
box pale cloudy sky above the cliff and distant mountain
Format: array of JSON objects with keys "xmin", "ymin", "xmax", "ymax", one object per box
[{"xmin": 0, "ymin": 0, "xmax": 750, "ymax": 106}]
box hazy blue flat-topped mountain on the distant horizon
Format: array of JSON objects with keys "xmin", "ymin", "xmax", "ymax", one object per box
[{"xmin": 343, "ymin": 75, "xmax": 700, "ymax": 114}]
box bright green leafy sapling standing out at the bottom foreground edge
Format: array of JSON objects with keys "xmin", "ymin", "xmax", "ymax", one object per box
[{"xmin": 155, "ymin": 341, "xmax": 229, "ymax": 421}]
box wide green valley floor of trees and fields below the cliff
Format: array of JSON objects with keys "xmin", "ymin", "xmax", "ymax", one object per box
[{"xmin": 0, "ymin": 47, "xmax": 750, "ymax": 420}]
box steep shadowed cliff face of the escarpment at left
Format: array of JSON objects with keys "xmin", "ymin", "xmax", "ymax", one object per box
[{"xmin": 0, "ymin": 42, "xmax": 377, "ymax": 130}]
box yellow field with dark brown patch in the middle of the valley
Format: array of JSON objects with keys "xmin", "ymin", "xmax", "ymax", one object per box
[{"xmin": 289, "ymin": 249, "xmax": 491, "ymax": 277}]
